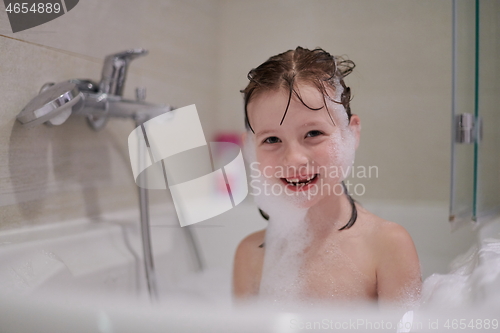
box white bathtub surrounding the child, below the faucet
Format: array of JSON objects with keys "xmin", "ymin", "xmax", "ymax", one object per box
[{"xmin": 0, "ymin": 201, "xmax": 500, "ymax": 333}]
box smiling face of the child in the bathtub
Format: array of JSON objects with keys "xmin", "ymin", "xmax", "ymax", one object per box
[{"xmin": 247, "ymin": 85, "xmax": 360, "ymax": 207}]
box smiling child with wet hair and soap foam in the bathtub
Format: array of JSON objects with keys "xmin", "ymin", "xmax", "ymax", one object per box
[{"xmin": 233, "ymin": 47, "xmax": 421, "ymax": 305}]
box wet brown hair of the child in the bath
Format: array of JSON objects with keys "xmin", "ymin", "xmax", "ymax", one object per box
[{"xmin": 240, "ymin": 46, "xmax": 358, "ymax": 230}]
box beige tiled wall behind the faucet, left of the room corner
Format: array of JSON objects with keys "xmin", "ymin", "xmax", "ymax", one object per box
[{"xmin": 0, "ymin": 0, "xmax": 217, "ymax": 229}]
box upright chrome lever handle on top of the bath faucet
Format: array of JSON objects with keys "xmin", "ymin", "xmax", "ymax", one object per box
[{"xmin": 99, "ymin": 49, "xmax": 148, "ymax": 96}]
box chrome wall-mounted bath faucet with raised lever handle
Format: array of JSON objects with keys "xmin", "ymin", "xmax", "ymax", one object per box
[{"xmin": 17, "ymin": 49, "xmax": 172, "ymax": 130}]
